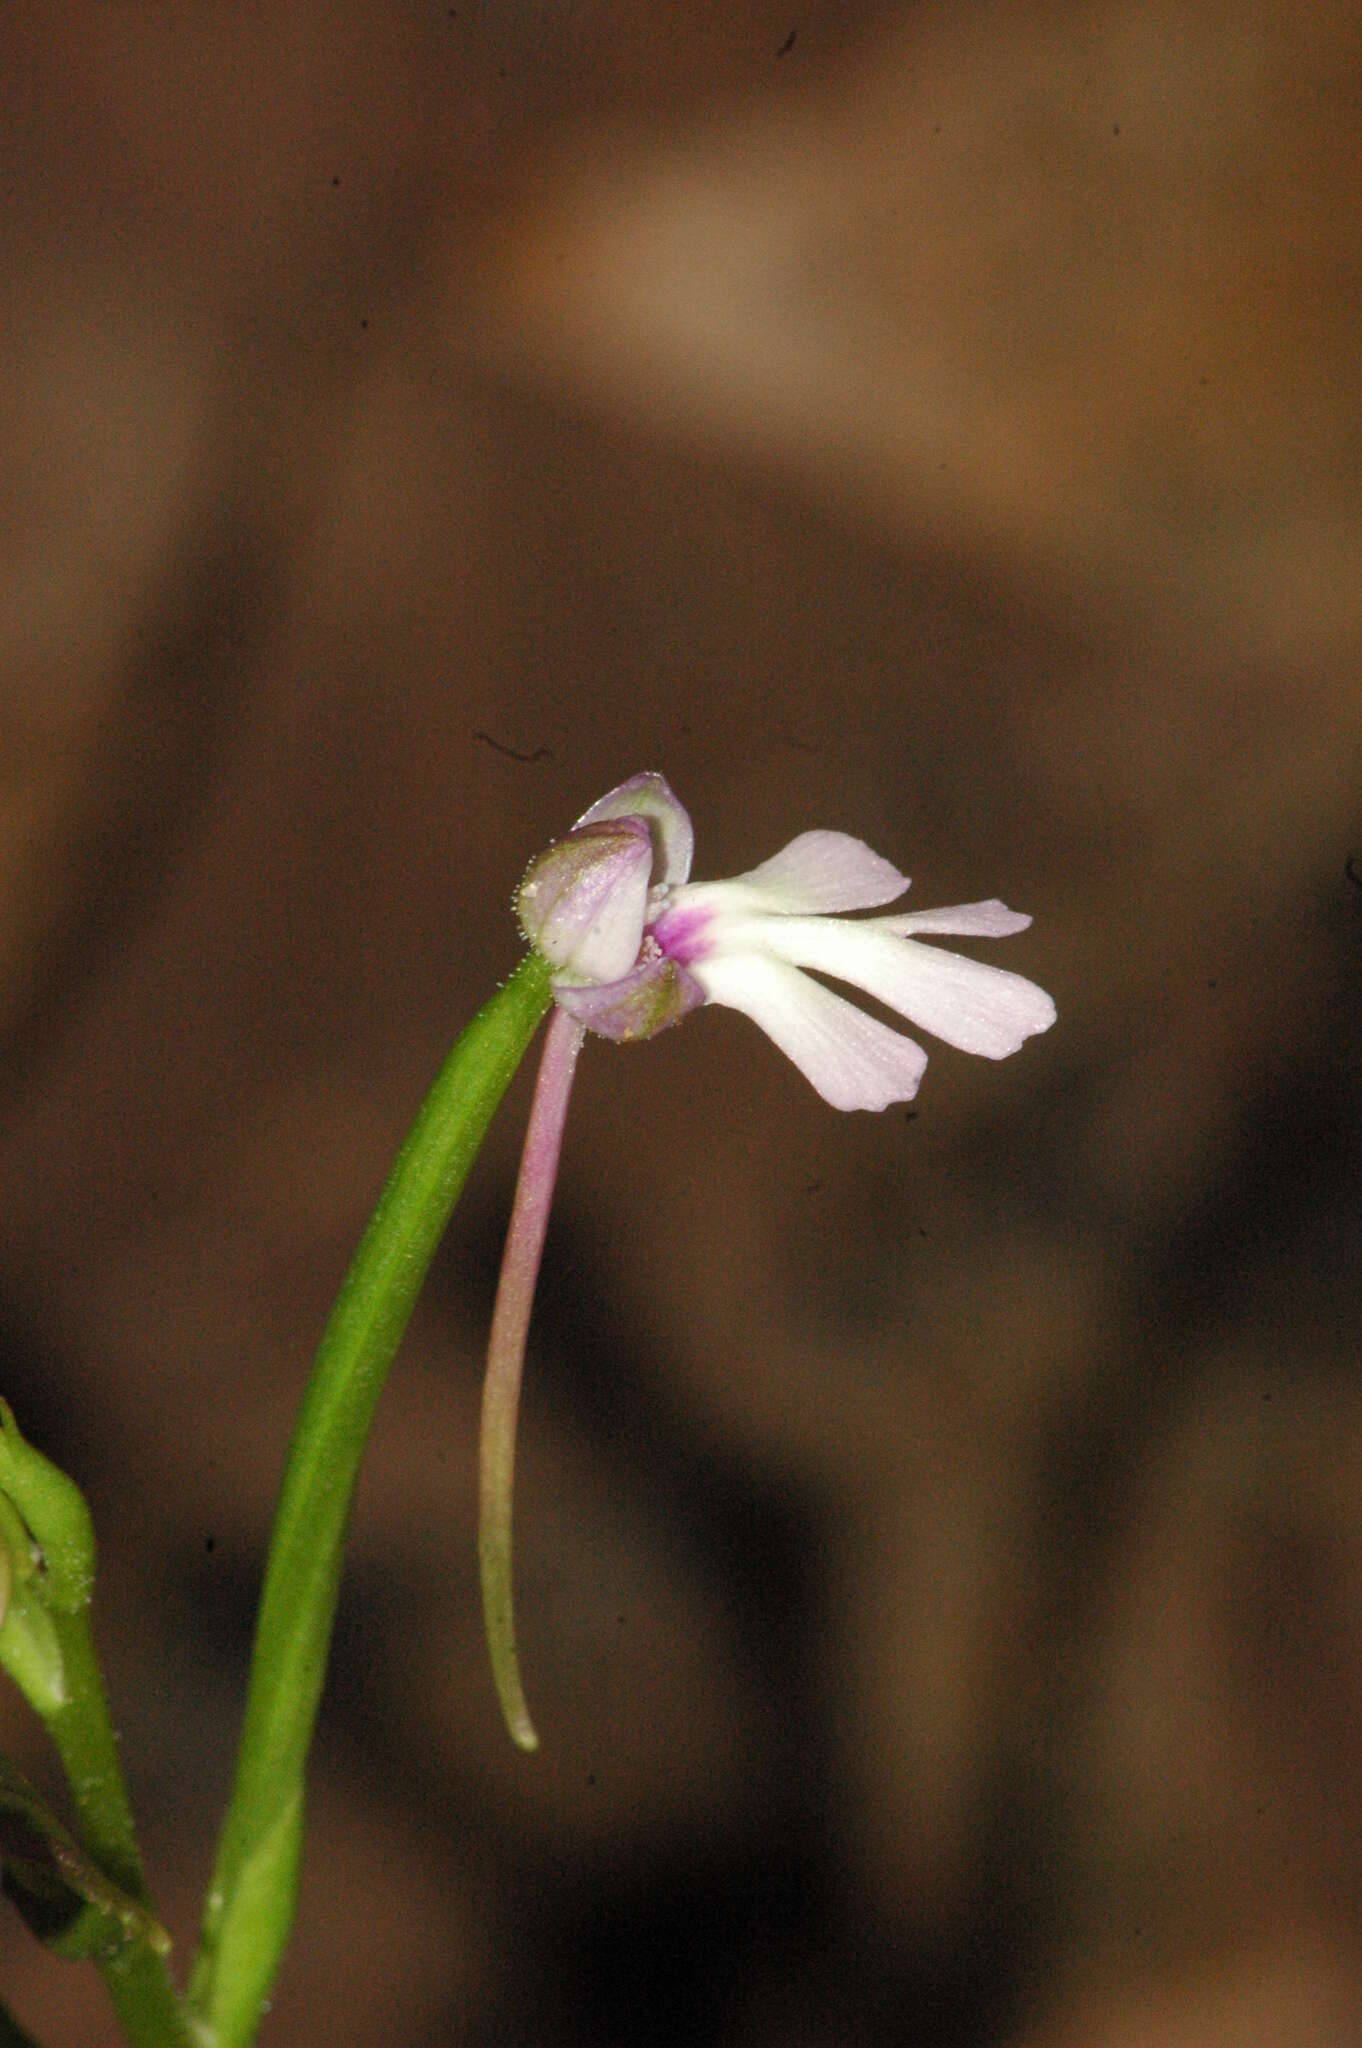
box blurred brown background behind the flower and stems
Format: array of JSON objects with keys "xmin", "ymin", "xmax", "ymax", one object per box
[{"xmin": 0, "ymin": 0, "xmax": 1362, "ymax": 2048}]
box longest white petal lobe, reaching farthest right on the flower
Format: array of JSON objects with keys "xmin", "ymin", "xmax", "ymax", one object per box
[{"xmin": 723, "ymin": 918, "xmax": 1055, "ymax": 1059}]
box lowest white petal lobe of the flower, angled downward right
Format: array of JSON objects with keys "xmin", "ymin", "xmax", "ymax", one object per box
[{"xmin": 694, "ymin": 954, "xmax": 928, "ymax": 1110}]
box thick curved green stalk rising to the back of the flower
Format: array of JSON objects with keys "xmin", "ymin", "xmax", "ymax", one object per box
[{"xmin": 190, "ymin": 954, "xmax": 549, "ymax": 2048}]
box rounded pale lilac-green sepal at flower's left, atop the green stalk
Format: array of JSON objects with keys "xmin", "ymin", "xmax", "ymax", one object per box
[{"xmin": 516, "ymin": 817, "xmax": 653, "ymax": 983}]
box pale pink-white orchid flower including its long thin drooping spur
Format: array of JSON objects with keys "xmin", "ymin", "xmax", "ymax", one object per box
[{"xmin": 479, "ymin": 774, "xmax": 1055, "ymax": 1749}]
